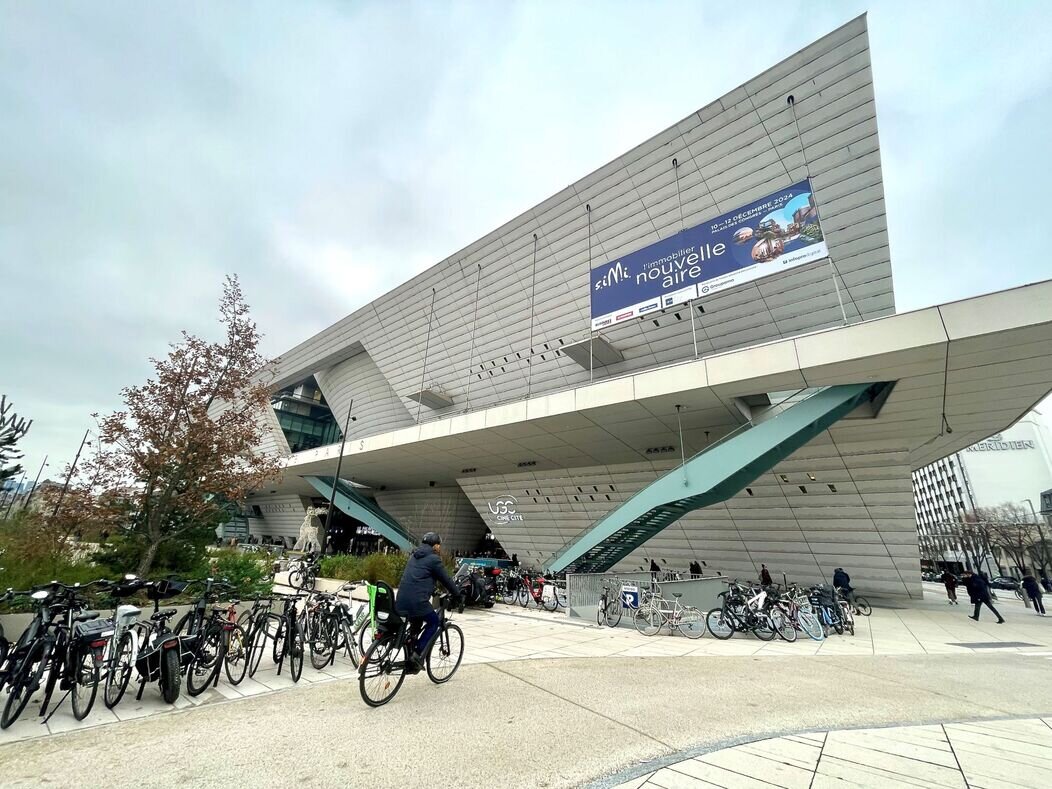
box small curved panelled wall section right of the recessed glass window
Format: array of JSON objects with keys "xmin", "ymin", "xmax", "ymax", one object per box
[{"xmin": 315, "ymin": 351, "xmax": 416, "ymax": 441}]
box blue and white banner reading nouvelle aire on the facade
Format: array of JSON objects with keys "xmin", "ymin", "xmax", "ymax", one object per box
[{"xmin": 591, "ymin": 181, "xmax": 829, "ymax": 329}]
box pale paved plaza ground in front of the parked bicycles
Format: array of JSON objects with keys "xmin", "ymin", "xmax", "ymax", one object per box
[{"xmin": 0, "ymin": 594, "xmax": 1052, "ymax": 787}]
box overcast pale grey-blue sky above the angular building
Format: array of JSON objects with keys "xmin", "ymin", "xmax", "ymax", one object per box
[{"xmin": 0, "ymin": 0, "xmax": 1052, "ymax": 486}]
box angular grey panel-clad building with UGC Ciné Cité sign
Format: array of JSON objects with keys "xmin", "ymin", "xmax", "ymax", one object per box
[{"xmin": 238, "ymin": 17, "xmax": 1052, "ymax": 595}]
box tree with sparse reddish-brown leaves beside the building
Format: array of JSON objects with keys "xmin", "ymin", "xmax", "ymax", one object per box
[{"xmin": 75, "ymin": 277, "xmax": 282, "ymax": 575}]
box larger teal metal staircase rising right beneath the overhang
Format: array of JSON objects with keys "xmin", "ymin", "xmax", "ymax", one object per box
[{"xmin": 545, "ymin": 383, "xmax": 893, "ymax": 572}]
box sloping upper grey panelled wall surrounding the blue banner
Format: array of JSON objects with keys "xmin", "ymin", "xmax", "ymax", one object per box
[{"xmin": 260, "ymin": 17, "xmax": 894, "ymax": 422}]
